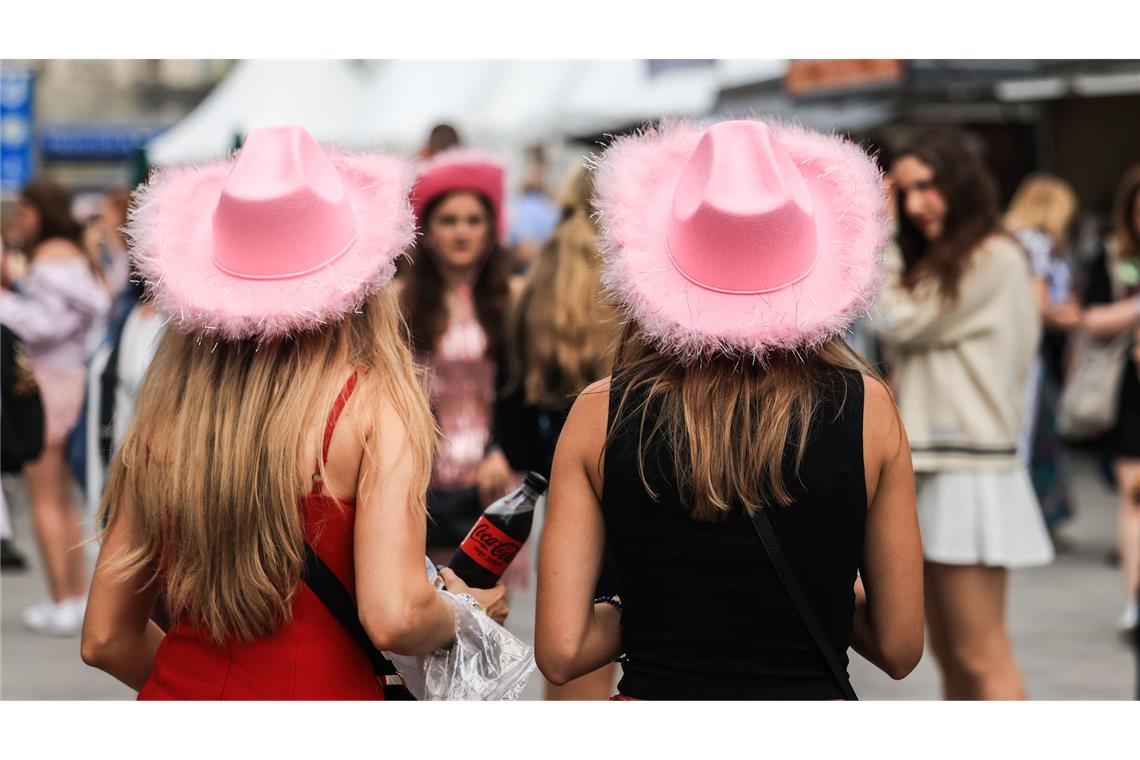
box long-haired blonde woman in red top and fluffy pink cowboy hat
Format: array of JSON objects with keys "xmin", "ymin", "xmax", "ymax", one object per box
[{"xmin": 82, "ymin": 126, "xmax": 506, "ymax": 700}]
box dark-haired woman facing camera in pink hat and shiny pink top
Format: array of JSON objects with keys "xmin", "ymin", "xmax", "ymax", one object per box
[{"xmin": 400, "ymin": 150, "xmax": 516, "ymax": 562}]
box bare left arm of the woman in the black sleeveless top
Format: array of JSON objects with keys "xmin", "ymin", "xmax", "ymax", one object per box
[{"xmin": 535, "ymin": 379, "xmax": 621, "ymax": 684}]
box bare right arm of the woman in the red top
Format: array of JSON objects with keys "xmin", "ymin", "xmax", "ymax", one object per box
[{"xmin": 355, "ymin": 391, "xmax": 455, "ymax": 655}]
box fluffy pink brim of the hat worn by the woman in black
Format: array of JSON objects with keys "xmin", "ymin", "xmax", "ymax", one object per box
[{"xmin": 594, "ymin": 121, "xmax": 888, "ymax": 361}]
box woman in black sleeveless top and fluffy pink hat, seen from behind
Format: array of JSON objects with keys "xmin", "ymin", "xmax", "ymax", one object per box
[{"xmin": 535, "ymin": 120, "xmax": 922, "ymax": 700}]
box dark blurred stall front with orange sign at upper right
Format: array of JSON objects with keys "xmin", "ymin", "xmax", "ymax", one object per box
[{"xmin": 715, "ymin": 59, "xmax": 1140, "ymax": 229}]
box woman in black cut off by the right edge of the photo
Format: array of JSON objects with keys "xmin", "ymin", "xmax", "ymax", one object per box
[{"xmin": 1084, "ymin": 164, "xmax": 1140, "ymax": 631}]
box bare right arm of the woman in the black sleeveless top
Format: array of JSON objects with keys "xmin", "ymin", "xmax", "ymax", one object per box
[{"xmin": 852, "ymin": 378, "xmax": 922, "ymax": 679}]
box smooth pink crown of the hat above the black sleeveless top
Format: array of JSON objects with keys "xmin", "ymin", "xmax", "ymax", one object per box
[{"xmin": 666, "ymin": 121, "xmax": 819, "ymax": 293}]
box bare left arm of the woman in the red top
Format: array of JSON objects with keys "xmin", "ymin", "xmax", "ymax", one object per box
[{"xmin": 80, "ymin": 496, "xmax": 164, "ymax": 692}]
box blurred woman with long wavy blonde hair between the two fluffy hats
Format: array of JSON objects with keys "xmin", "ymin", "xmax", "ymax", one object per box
[{"xmin": 495, "ymin": 164, "xmax": 618, "ymax": 700}]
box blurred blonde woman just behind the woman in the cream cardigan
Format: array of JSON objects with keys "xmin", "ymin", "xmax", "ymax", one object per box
[{"xmin": 1004, "ymin": 173, "xmax": 1081, "ymax": 537}]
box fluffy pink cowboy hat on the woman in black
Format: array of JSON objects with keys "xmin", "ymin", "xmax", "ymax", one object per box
[{"xmin": 596, "ymin": 120, "xmax": 887, "ymax": 360}]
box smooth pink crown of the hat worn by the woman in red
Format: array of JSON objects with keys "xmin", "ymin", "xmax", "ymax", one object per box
[{"xmin": 212, "ymin": 126, "xmax": 356, "ymax": 279}]
